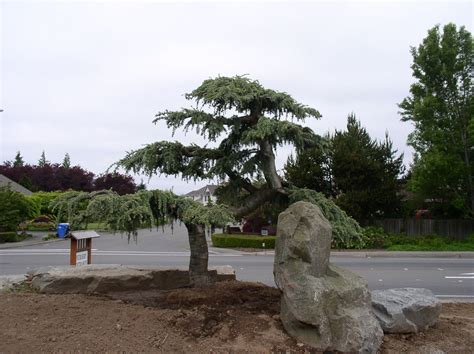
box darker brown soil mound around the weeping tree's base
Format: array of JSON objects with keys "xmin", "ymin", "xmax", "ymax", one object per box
[{"xmin": 109, "ymin": 282, "xmax": 286, "ymax": 342}]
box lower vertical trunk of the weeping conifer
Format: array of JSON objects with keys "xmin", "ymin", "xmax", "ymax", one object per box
[{"xmin": 186, "ymin": 224, "xmax": 211, "ymax": 287}]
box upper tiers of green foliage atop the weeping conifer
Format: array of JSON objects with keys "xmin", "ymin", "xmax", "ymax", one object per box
[{"xmin": 117, "ymin": 76, "xmax": 321, "ymax": 188}]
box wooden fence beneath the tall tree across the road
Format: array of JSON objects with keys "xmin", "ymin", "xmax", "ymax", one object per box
[{"xmin": 375, "ymin": 219, "xmax": 474, "ymax": 240}]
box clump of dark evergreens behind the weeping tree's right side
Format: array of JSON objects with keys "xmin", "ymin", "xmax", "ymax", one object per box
[{"xmin": 285, "ymin": 114, "xmax": 404, "ymax": 222}]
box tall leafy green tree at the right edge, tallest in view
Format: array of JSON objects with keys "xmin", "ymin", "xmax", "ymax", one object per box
[{"xmin": 399, "ymin": 24, "xmax": 474, "ymax": 217}]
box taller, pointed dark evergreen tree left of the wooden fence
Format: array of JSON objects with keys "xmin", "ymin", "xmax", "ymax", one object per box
[{"xmin": 331, "ymin": 114, "xmax": 404, "ymax": 222}]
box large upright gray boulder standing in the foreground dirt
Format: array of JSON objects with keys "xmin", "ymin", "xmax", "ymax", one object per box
[{"xmin": 274, "ymin": 202, "xmax": 383, "ymax": 353}]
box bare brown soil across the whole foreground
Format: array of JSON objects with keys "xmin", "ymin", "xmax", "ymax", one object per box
[{"xmin": 0, "ymin": 282, "xmax": 474, "ymax": 353}]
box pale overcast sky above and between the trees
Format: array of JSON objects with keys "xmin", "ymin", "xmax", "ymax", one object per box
[{"xmin": 0, "ymin": 1, "xmax": 473, "ymax": 193}]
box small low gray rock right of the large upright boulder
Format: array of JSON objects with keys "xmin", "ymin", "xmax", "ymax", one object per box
[{"xmin": 372, "ymin": 288, "xmax": 441, "ymax": 333}]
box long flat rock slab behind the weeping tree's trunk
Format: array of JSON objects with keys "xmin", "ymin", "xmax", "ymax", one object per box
[{"xmin": 28, "ymin": 264, "xmax": 235, "ymax": 294}]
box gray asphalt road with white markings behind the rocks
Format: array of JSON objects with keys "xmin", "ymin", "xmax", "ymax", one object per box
[{"xmin": 0, "ymin": 225, "xmax": 474, "ymax": 300}]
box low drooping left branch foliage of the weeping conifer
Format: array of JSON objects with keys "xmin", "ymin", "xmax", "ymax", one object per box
[{"xmin": 51, "ymin": 190, "xmax": 233, "ymax": 236}]
